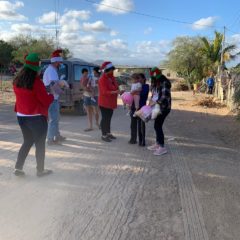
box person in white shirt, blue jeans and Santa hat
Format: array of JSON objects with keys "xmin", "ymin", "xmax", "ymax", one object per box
[{"xmin": 43, "ymin": 49, "xmax": 66, "ymax": 145}]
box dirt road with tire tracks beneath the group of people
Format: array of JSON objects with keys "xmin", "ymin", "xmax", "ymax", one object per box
[{"xmin": 0, "ymin": 93, "xmax": 240, "ymax": 240}]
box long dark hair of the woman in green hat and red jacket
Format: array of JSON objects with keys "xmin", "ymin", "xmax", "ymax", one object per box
[{"xmin": 13, "ymin": 68, "xmax": 37, "ymax": 90}]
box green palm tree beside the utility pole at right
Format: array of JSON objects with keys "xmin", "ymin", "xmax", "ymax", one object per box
[{"xmin": 200, "ymin": 31, "xmax": 240, "ymax": 72}]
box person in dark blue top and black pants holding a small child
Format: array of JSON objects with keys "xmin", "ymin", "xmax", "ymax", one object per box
[{"xmin": 128, "ymin": 73, "xmax": 149, "ymax": 146}]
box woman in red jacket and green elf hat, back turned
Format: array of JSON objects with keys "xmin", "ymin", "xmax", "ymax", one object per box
[{"xmin": 13, "ymin": 53, "xmax": 53, "ymax": 177}]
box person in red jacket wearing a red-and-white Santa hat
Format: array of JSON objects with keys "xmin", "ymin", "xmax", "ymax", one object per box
[{"xmin": 98, "ymin": 62, "xmax": 119, "ymax": 142}]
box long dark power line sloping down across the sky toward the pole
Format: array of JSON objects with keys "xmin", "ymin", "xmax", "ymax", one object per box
[{"xmin": 84, "ymin": 0, "xmax": 222, "ymax": 28}]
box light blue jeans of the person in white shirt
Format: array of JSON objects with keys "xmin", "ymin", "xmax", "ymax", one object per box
[{"xmin": 47, "ymin": 100, "xmax": 60, "ymax": 140}]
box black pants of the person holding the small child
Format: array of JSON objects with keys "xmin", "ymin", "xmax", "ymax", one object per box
[{"xmin": 130, "ymin": 116, "xmax": 145, "ymax": 145}]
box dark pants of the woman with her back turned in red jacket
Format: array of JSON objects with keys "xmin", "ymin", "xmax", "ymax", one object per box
[{"xmin": 15, "ymin": 116, "xmax": 48, "ymax": 171}]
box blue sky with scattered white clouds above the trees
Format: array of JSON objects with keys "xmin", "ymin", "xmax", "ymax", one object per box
[{"xmin": 0, "ymin": 0, "xmax": 240, "ymax": 65}]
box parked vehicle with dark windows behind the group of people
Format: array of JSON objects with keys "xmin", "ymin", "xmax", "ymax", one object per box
[{"xmin": 40, "ymin": 58, "xmax": 97, "ymax": 115}]
